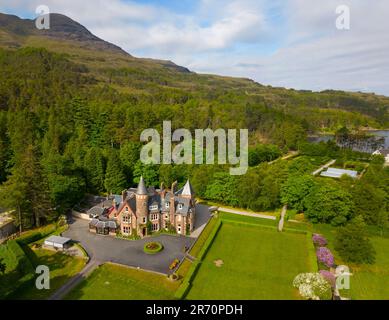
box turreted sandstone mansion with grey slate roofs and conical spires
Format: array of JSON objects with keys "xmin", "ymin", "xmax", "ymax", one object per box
[{"xmin": 89, "ymin": 177, "xmax": 196, "ymax": 238}]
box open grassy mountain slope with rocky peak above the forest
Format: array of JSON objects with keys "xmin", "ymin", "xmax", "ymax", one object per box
[{"xmin": 0, "ymin": 13, "xmax": 389, "ymax": 129}]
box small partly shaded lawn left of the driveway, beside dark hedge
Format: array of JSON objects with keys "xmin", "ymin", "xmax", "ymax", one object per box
[{"xmin": 11, "ymin": 248, "xmax": 85, "ymax": 300}]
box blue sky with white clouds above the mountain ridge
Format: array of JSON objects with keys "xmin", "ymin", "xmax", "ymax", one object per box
[{"xmin": 0, "ymin": 0, "xmax": 389, "ymax": 96}]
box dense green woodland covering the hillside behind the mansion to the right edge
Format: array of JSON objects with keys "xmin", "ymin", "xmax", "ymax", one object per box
[{"xmin": 0, "ymin": 48, "xmax": 389, "ymax": 228}]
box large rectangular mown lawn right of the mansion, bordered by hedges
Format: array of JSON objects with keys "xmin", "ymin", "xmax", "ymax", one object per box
[{"xmin": 186, "ymin": 222, "xmax": 311, "ymax": 300}]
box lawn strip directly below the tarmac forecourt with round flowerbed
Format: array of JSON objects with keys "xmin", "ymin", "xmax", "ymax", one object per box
[{"xmin": 66, "ymin": 263, "xmax": 179, "ymax": 300}]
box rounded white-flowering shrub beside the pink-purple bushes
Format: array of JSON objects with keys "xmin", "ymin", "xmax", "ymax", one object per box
[{"xmin": 293, "ymin": 273, "xmax": 332, "ymax": 300}]
